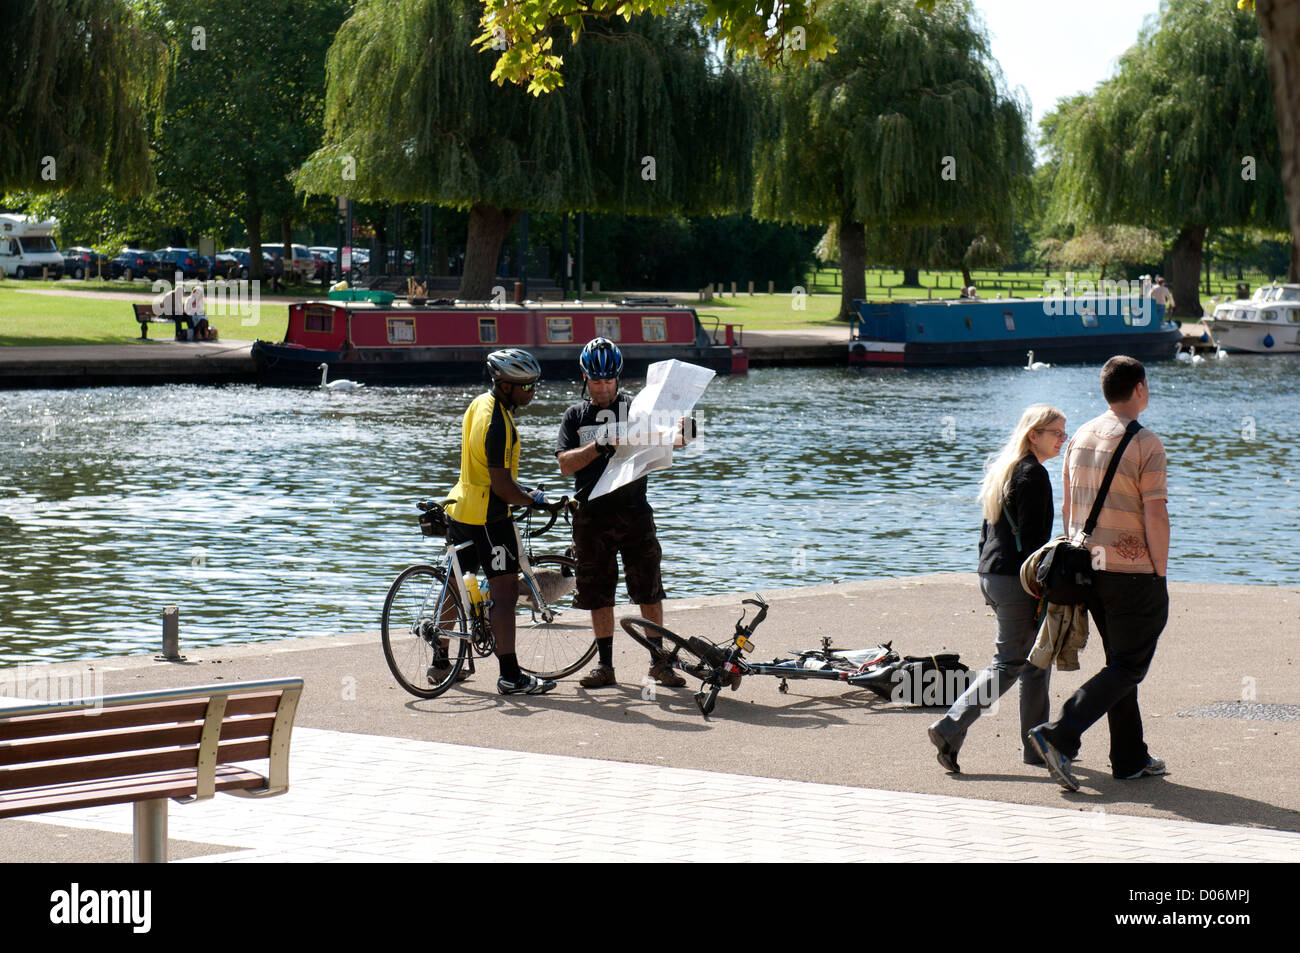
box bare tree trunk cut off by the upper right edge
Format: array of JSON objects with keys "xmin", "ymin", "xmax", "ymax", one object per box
[{"xmin": 1255, "ymin": 0, "xmax": 1300, "ymax": 281}]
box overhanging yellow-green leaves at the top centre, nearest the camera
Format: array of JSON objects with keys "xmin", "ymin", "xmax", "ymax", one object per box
[{"xmin": 473, "ymin": 0, "xmax": 835, "ymax": 95}]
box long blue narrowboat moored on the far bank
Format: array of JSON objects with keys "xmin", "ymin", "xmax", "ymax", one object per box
[{"xmin": 849, "ymin": 294, "xmax": 1182, "ymax": 367}]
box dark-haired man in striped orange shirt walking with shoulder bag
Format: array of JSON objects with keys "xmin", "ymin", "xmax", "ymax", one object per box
[{"xmin": 1028, "ymin": 356, "xmax": 1169, "ymax": 790}]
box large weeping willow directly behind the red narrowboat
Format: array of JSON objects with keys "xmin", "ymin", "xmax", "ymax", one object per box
[{"xmin": 295, "ymin": 0, "xmax": 753, "ymax": 299}]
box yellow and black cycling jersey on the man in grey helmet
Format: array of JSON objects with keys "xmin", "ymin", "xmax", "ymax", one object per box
[{"xmin": 447, "ymin": 393, "xmax": 519, "ymax": 527}]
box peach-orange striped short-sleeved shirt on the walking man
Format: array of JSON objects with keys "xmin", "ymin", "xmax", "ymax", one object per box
[{"xmin": 1062, "ymin": 411, "xmax": 1169, "ymax": 572}]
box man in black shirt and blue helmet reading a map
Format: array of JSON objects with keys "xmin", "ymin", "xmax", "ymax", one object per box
[{"xmin": 555, "ymin": 338, "xmax": 694, "ymax": 688}]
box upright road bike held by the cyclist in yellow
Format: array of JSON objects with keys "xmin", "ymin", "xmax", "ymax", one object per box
[{"xmin": 381, "ymin": 497, "xmax": 595, "ymax": 698}]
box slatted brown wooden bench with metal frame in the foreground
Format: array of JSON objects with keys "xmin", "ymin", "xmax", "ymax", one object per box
[{"xmin": 0, "ymin": 679, "xmax": 303, "ymax": 863}]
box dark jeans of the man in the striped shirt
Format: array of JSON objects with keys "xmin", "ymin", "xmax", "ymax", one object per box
[{"xmin": 1043, "ymin": 572, "xmax": 1169, "ymax": 777}]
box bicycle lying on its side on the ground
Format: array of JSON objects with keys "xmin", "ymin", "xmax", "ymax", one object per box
[{"xmin": 621, "ymin": 593, "xmax": 969, "ymax": 719}]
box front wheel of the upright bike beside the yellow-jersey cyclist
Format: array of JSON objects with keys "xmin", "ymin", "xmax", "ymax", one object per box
[{"xmin": 515, "ymin": 556, "xmax": 595, "ymax": 679}]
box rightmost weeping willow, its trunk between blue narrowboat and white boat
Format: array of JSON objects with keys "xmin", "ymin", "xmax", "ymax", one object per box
[{"xmin": 1049, "ymin": 0, "xmax": 1287, "ymax": 317}]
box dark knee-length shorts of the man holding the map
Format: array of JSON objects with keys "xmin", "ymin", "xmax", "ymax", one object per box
[{"xmin": 573, "ymin": 506, "xmax": 664, "ymax": 610}]
